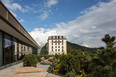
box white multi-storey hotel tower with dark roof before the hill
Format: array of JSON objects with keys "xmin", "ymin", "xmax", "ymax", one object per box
[{"xmin": 47, "ymin": 36, "xmax": 67, "ymax": 55}]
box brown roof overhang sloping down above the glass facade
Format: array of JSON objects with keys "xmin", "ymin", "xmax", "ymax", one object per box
[{"xmin": 0, "ymin": 1, "xmax": 40, "ymax": 49}]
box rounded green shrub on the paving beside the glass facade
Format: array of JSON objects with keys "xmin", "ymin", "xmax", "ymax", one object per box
[{"xmin": 23, "ymin": 54, "xmax": 38, "ymax": 67}]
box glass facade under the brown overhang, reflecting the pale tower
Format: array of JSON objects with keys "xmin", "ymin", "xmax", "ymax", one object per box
[{"xmin": 0, "ymin": 31, "xmax": 37, "ymax": 66}]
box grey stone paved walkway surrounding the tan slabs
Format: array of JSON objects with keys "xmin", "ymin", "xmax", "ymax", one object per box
[{"xmin": 0, "ymin": 63, "xmax": 61, "ymax": 77}]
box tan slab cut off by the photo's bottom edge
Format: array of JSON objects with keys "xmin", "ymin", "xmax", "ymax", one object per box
[{"xmin": 3, "ymin": 72, "xmax": 48, "ymax": 77}]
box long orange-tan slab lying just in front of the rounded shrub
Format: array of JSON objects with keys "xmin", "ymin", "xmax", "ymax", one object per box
[{"xmin": 15, "ymin": 67, "xmax": 44, "ymax": 73}]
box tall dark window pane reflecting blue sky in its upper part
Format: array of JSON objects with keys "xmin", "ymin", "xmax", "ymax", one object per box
[{"xmin": 4, "ymin": 34, "xmax": 11, "ymax": 65}]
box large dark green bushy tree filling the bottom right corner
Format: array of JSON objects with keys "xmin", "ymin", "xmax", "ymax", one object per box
[{"xmin": 89, "ymin": 47, "xmax": 116, "ymax": 77}]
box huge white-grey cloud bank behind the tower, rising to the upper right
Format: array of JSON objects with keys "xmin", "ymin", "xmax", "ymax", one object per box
[{"xmin": 30, "ymin": 0, "xmax": 116, "ymax": 47}]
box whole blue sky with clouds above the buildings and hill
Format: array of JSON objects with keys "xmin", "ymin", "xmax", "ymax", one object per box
[{"xmin": 2, "ymin": 0, "xmax": 116, "ymax": 48}]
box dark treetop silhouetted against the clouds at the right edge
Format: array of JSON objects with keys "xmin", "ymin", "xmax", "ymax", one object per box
[{"xmin": 102, "ymin": 34, "xmax": 115, "ymax": 47}]
